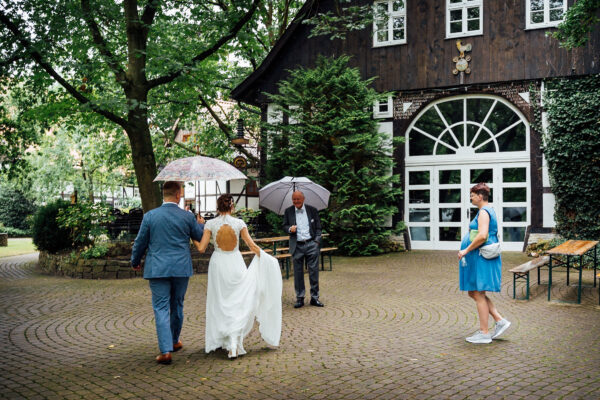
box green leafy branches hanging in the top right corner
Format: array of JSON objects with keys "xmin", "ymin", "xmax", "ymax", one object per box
[{"xmin": 549, "ymin": 0, "xmax": 600, "ymax": 50}]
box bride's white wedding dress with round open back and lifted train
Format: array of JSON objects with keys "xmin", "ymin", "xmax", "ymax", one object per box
[{"xmin": 204, "ymin": 215, "xmax": 282, "ymax": 355}]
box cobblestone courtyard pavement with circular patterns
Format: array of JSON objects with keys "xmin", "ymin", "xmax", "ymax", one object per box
[{"xmin": 0, "ymin": 251, "xmax": 600, "ymax": 399}]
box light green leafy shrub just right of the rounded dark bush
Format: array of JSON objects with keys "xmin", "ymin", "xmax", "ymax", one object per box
[{"xmin": 56, "ymin": 202, "xmax": 115, "ymax": 246}]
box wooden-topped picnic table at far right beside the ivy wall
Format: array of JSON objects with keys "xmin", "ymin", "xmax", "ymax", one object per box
[{"xmin": 548, "ymin": 240, "xmax": 598, "ymax": 304}]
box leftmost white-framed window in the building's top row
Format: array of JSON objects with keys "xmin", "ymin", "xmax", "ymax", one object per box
[{"xmin": 373, "ymin": 0, "xmax": 406, "ymax": 47}]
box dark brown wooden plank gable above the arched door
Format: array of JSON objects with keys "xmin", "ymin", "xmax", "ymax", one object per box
[{"xmin": 233, "ymin": 0, "xmax": 600, "ymax": 105}]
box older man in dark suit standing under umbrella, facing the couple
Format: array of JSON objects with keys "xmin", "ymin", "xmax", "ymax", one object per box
[{"xmin": 283, "ymin": 191, "xmax": 323, "ymax": 308}]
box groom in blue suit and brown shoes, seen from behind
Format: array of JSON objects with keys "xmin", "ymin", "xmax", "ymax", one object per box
[{"xmin": 131, "ymin": 182, "xmax": 204, "ymax": 364}]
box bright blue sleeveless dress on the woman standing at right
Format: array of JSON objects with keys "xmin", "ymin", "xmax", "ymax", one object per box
[{"xmin": 459, "ymin": 206, "xmax": 502, "ymax": 292}]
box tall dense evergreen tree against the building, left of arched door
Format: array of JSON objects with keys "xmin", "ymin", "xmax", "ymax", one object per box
[{"xmin": 267, "ymin": 56, "xmax": 402, "ymax": 255}]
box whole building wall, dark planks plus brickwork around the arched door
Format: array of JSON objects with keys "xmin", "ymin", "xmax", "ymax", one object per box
[{"xmin": 232, "ymin": 0, "xmax": 600, "ymax": 250}]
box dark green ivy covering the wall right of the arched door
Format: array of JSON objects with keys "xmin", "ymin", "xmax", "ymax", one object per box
[{"xmin": 543, "ymin": 75, "xmax": 600, "ymax": 239}]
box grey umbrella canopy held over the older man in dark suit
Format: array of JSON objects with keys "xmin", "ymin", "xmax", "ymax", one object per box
[{"xmin": 258, "ymin": 176, "xmax": 330, "ymax": 215}]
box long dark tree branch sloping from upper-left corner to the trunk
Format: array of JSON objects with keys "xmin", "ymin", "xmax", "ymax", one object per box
[{"xmin": 0, "ymin": 9, "xmax": 127, "ymax": 128}]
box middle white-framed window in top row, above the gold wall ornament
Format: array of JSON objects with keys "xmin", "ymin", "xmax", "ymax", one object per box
[{"xmin": 446, "ymin": 0, "xmax": 483, "ymax": 38}]
